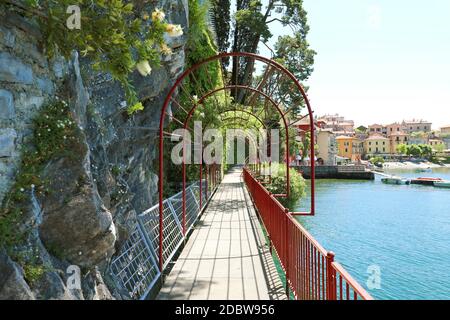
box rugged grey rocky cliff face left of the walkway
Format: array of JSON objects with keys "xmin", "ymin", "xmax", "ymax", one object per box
[{"xmin": 0, "ymin": 0, "xmax": 188, "ymax": 299}]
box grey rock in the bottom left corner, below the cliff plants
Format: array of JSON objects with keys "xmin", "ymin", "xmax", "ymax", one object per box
[{"xmin": 0, "ymin": 251, "xmax": 35, "ymax": 300}]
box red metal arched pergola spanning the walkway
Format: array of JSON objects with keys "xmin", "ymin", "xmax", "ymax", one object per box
[{"xmin": 158, "ymin": 52, "xmax": 315, "ymax": 268}]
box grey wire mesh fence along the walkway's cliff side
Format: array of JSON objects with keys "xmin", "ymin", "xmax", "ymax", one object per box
[{"xmin": 110, "ymin": 181, "xmax": 221, "ymax": 299}]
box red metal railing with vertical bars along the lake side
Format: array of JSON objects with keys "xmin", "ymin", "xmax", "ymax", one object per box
[{"xmin": 244, "ymin": 169, "xmax": 372, "ymax": 300}]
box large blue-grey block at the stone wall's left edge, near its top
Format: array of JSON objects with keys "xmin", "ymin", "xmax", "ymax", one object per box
[{"xmin": 0, "ymin": 52, "xmax": 33, "ymax": 84}]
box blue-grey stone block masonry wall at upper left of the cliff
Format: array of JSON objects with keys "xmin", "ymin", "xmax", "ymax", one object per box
[{"xmin": 0, "ymin": 10, "xmax": 64, "ymax": 201}]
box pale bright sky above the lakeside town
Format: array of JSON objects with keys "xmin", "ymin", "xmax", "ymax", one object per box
[{"xmin": 260, "ymin": 0, "xmax": 450, "ymax": 129}]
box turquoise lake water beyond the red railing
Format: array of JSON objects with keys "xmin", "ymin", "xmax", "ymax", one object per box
[{"xmin": 297, "ymin": 169, "xmax": 450, "ymax": 299}]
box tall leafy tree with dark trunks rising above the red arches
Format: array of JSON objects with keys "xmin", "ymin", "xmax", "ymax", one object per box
[{"xmin": 231, "ymin": 0, "xmax": 316, "ymax": 102}]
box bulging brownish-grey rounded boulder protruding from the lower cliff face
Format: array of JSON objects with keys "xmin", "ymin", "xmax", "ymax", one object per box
[{"xmin": 39, "ymin": 137, "xmax": 116, "ymax": 267}]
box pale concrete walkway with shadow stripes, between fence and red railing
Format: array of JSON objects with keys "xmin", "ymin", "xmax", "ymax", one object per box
[{"xmin": 158, "ymin": 168, "xmax": 286, "ymax": 300}]
